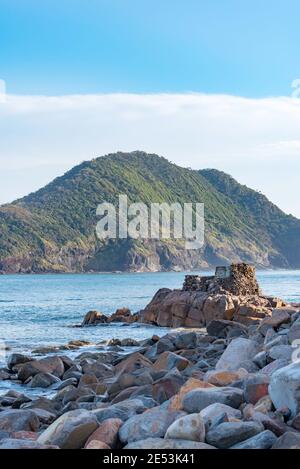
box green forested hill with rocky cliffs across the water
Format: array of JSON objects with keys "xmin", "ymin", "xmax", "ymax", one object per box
[{"xmin": 0, "ymin": 151, "xmax": 300, "ymax": 273}]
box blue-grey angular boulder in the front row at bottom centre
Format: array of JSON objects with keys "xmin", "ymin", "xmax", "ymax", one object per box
[{"xmin": 119, "ymin": 407, "xmax": 184, "ymax": 443}]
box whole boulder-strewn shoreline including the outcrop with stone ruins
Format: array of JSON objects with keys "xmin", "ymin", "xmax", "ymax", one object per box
[{"xmin": 0, "ymin": 266, "xmax": 300, "ymax": 450}]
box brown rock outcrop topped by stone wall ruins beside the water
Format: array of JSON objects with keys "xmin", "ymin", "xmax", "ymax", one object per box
[{"xmin": 138, "ymin": 264, "xmax": 284, "ymax": 327}]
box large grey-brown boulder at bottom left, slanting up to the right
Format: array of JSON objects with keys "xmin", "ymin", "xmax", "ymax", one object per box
[{"xmin": 37, "ymin": 409, "xmax": 98, "ymax": 449}]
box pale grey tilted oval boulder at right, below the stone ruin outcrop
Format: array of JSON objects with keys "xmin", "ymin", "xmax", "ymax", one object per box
[{"xmin": 216, "ymin": 337, "xmax": 258, "ymax": 371}]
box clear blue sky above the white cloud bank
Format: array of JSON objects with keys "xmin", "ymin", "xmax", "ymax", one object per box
[{"xmin": 0, "ymin": 0, "xmax": 300, "ymax": 97}]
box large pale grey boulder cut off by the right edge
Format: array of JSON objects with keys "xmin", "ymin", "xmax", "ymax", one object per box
[{"xmin": 269, "ymin": 362, "xmax": 300, "ymax": 417}]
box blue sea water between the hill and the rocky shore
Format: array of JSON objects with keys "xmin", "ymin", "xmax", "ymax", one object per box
[{"xmin": 0, "ymin": 271, "xmax": 300, "ymax": 351}]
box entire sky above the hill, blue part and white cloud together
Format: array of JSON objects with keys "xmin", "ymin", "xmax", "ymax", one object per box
[{"xmin": 0, "ymin": 0, "xmax": 300, "ymax": 218}]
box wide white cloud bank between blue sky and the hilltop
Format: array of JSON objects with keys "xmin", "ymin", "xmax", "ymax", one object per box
[{"xmin": 0, "ymin": 93, "xmax": 300, "ymax": 217}]
